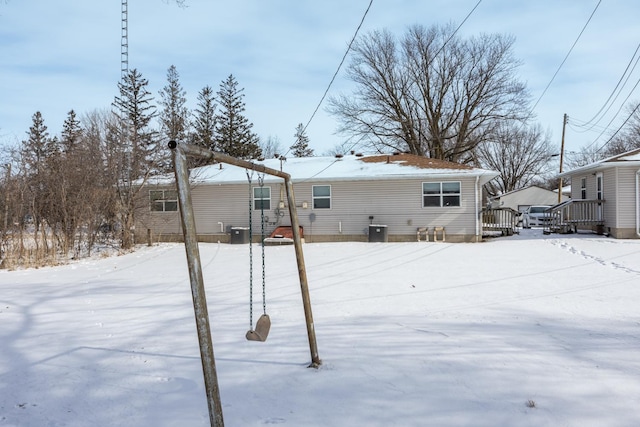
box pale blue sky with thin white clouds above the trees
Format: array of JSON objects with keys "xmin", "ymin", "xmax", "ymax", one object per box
[{"xmin": 0, "ymin": 0, "xmax": 640, "ymax": 158}]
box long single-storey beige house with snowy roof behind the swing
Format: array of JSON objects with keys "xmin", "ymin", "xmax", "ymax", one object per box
[{"xmin": 136, "ymin": 154, "xmax": 498, "ymax": 242}]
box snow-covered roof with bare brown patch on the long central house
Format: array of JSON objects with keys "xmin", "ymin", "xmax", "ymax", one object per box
[{"xmin": 150, "ymin": 154, "xmax": 498, "ymax": 184}]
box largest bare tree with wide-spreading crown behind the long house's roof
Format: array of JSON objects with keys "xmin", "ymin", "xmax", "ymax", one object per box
[{"xmin": 329, "ymin": 25, "xmax": 529, "ymax": 162}]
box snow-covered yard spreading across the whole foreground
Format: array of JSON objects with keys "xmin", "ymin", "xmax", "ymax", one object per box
[{"xmin": 0, "ymin": 229, "xmax": 640, "ymax": 427}]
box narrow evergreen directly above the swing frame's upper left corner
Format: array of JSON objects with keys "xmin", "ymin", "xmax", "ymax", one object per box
[{"xmin": 160, "ymin": 65, "xmax": 189, "ymax": 141}]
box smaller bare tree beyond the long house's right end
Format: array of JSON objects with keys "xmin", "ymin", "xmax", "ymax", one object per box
[{"xmin": 476, "ymin": 122, "xmax": 554, "ymax": 195}]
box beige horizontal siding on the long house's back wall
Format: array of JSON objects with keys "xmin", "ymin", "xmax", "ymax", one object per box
[{"xmin": 144, "ymin": 177, "xmax": 481, "ymax": 241}]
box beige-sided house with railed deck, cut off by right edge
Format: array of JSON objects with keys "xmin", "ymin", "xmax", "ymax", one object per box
[{"xmin": 560, "ymin": 149, "xmax": 640, "ymax": 239}]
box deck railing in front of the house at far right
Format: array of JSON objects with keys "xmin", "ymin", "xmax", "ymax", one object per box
[{"xmin": 543, "ymin": 199, "xmax": 604, "ymax": 234}]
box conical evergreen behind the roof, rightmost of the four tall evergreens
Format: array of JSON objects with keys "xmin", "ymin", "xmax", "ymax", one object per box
[{"xmin": 214, "ymin": 74, "xmax": 261, "ymax": 159}]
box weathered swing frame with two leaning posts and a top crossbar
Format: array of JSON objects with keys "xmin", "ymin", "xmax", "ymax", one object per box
[{"xmin": 169, "ymin": 141, "xmax": 322, "ymax": 427}]
